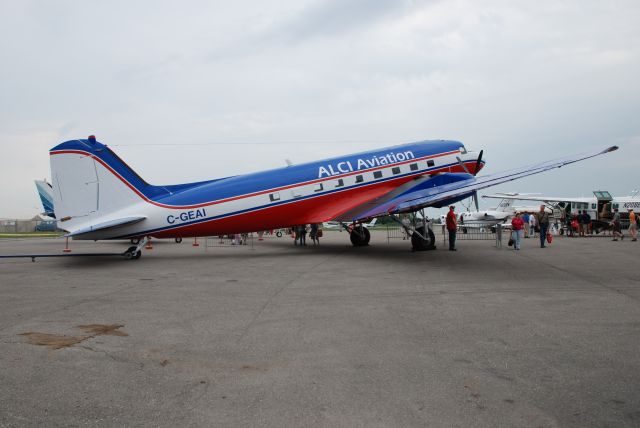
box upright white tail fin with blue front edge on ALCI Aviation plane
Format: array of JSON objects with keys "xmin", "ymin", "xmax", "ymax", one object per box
[{"xmin": 50, "ymin": 136, "xmax": 157, "ymax": 232}]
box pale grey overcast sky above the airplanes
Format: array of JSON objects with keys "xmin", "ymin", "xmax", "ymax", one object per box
[{"xmin": 0, "ymin": 0, "xmax": 640, "ymax": 217}]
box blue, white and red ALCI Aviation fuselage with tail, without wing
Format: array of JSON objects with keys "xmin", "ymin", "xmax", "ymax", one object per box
[{"xmin": 51, "ymin": 140, "xmax": 484, "ymax": 239}]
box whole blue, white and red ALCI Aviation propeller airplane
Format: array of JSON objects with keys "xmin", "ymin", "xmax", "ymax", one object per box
[{"xmin": 50, "ymin": 136, "xmax": 617, "ymax": 258}]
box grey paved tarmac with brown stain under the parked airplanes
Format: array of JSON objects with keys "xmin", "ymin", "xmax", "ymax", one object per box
[{"xmin": 0, "ymin": 232, "xmax": 640, "ymax": 427}]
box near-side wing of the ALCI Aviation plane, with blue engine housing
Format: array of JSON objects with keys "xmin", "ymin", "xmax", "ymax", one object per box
[{"xmin": 337, "ymin": 146, "xmax": 618, "ymax": 221}]
